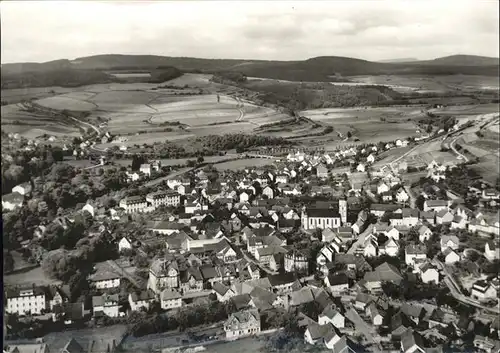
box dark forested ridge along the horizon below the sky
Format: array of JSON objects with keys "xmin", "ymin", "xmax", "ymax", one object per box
[{"xmin": 1, "ymin": 54, "xmax": 499, "ymax": 88}]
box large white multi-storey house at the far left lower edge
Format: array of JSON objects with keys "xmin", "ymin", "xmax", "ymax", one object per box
[{"xmin": 5, "ymin": 285, "xmax": 47, "ymax": 316}]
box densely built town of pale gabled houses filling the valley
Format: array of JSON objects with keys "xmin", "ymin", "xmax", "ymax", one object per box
[{"xmin": 2, "ymin": 128, "xmax": 500, "ymax": 353}]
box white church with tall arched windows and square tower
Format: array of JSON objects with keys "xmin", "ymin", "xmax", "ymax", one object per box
[{"xmin": 301, "ymin": 199, "xmax": 347, "ymax": 230}]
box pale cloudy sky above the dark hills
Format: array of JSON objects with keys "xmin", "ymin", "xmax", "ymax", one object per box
[{"xmin": 0, "ymin": 0, "xmax": 499, "ymax": 63}]
